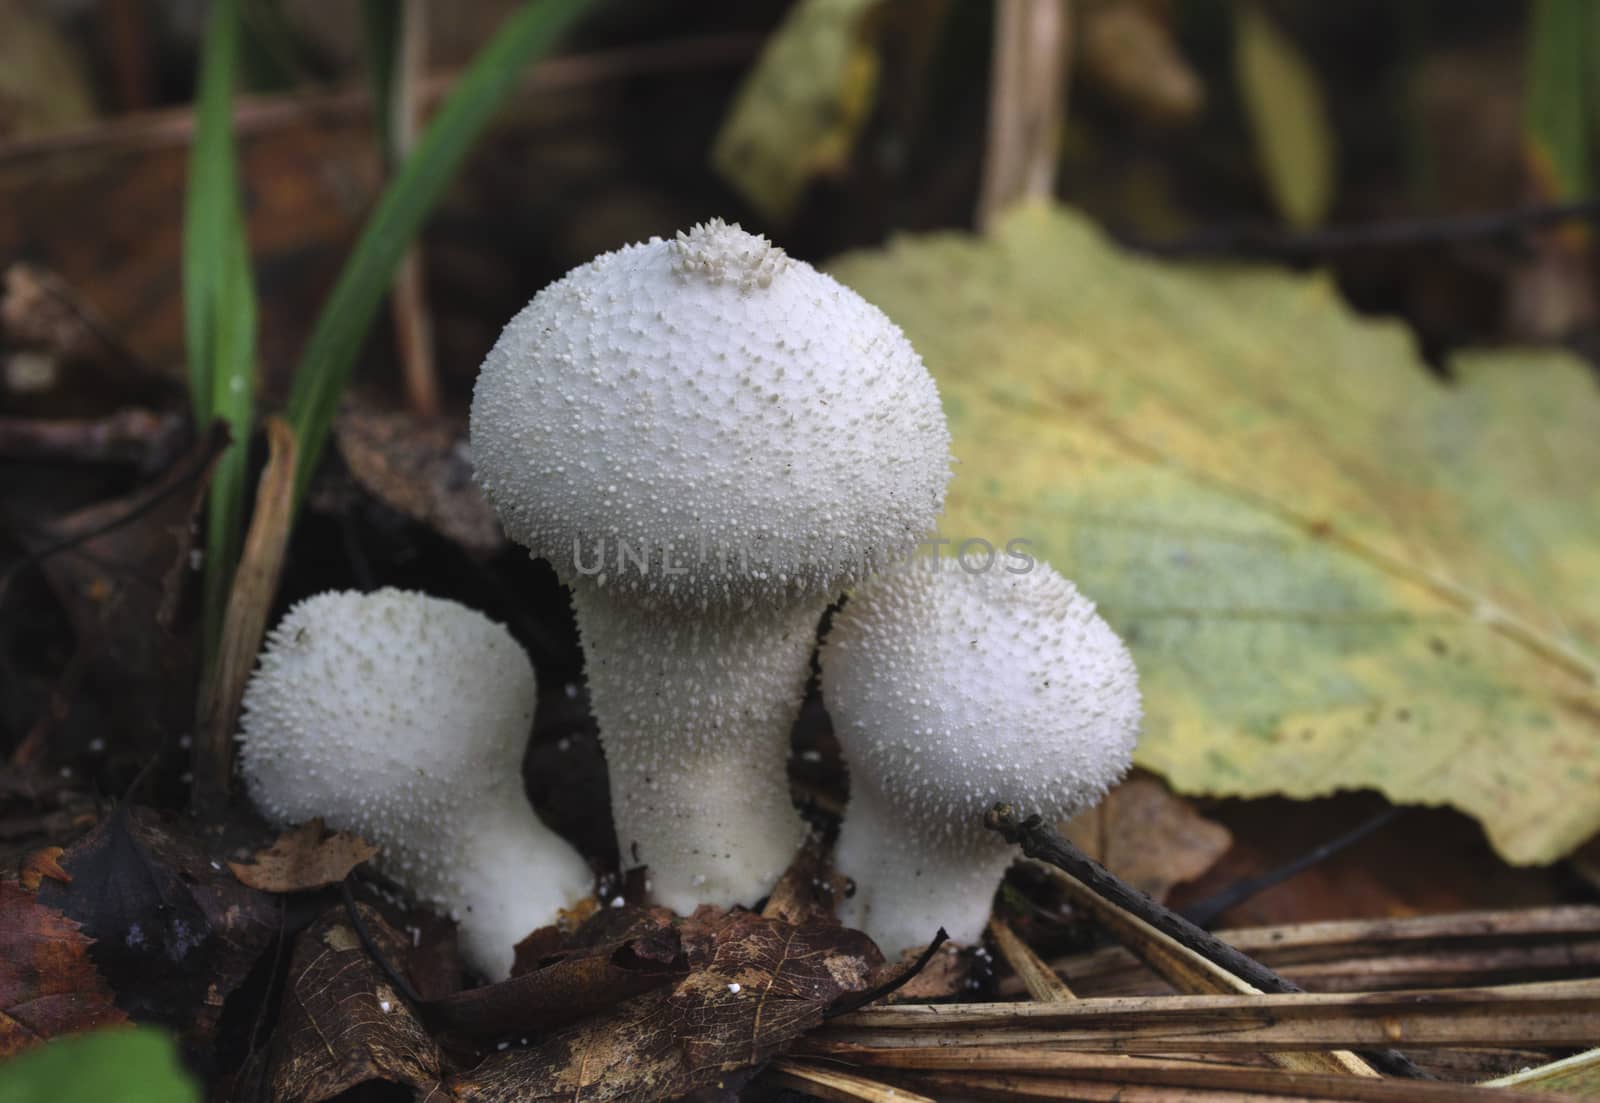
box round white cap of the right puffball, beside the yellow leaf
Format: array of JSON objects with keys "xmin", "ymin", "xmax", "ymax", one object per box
[{"xmin": 821, "ymin": 557, "xmax": 1141, "ymax": 840}]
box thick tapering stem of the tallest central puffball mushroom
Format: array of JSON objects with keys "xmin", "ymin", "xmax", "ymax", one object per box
[{"xmin": 573, "ymin": 580, "xmax": 827, "ymax": 914}]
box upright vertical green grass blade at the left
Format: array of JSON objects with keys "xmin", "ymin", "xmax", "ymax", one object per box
[{"xmin": 182, "ymin": 0, "xmax": 256, "ymax": 655}]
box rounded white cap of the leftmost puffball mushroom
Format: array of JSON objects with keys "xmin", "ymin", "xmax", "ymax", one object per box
[{"xmin": 240, "ymin": 589, "xmax": 538, "ymax": 810}]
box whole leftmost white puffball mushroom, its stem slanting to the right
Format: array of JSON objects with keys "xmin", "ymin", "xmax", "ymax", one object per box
[{"xmin": 238, "ymin": 589, "xmax": 594, "ymax": 980}]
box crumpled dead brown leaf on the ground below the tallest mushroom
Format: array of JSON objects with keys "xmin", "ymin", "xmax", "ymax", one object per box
[{"xmin": 450, "ymin": 908, "xmax": 882, "ymax": 1103}]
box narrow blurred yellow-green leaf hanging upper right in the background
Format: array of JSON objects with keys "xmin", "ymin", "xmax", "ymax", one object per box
[{"xmin": 1234, "ymin": 3, "xmax": 1336, "ymax": 227}]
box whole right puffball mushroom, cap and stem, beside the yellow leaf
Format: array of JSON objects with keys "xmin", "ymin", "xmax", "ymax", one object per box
[{"xmin": 822, "ymin": 559, "xmax": 1141, "ymax": 954}]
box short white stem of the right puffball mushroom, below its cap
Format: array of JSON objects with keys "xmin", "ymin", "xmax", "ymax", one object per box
[{"xmin": 834, "ymin": 778, "xmax": 1016, "ymax": 961}]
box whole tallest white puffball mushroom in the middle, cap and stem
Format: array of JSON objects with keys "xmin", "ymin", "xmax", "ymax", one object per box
[{"xmin": 470, "ymin": 221, "xmax": 950, "ymax": 912}]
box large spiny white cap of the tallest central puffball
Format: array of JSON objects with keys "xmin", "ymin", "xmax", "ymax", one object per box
[{"xmin": 472, "ymin": 221, "xmax": 950, "ymax": 607}]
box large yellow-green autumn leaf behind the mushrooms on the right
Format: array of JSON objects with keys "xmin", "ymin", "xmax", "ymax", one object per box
[{"xmin": 832, "ymin": 208, "xmax": 1600, "ymax": 863}]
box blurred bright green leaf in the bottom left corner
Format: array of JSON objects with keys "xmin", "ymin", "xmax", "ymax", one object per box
[{"xmin": 0, "ymin": 1026, "xmax": 200, "ymax": 1103}]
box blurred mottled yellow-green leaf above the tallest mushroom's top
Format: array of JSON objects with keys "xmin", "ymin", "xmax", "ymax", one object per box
[{"xmin": 712, "ymin": 0, "xmax": 878, "ymax": 219}]
